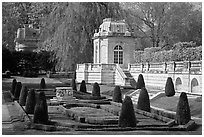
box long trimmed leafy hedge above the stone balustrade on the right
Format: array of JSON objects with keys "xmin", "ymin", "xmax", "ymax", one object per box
[{"xmin": 134, "ymin": 42, "xmax": 202, "ymax": 63}]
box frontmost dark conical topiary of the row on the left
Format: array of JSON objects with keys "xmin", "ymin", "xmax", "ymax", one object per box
[{"xmin": 33, "ymin": 91, "xmax": 48, "ymax": 124}]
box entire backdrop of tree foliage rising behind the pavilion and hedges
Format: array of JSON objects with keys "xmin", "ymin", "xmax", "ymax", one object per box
[{"xmin": 2, "ymin": 2, "xmax": 202, "ymax": 71}]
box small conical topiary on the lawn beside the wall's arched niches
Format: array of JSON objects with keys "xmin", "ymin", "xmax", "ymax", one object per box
[{"xmin": 165, "ymin": 77, "xmax": 175, "ymax": 97}]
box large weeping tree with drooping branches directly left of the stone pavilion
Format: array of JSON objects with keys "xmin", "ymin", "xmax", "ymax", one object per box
[{"xmin": 41, "ymin": 2, "xmax": 121, "ymax": 71}]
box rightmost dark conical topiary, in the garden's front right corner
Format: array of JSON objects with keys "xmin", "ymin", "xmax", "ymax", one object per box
[{"xmin": 176, "ymin": 92, "xmax": 191, "ymax": 125}]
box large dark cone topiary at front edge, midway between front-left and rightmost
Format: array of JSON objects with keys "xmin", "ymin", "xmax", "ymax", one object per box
[{"xmin": 118, "ymin": 96, "xmax": 137, "ymax": 127}]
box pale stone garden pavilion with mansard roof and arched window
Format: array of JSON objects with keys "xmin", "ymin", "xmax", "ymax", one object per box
[{"xmin": 93, "ymin": 18, "xmax": 136, "ymax": 68}]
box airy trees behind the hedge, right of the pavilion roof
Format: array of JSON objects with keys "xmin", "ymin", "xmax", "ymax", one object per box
[{"xmin": 122, "ymin": 2, "xmax": 202, "ymax": 49}]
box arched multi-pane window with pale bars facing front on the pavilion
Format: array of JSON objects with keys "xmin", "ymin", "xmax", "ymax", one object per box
[{"xmin": 114, "ymin": 45, "xmax": 123, "ymax": 64}]
